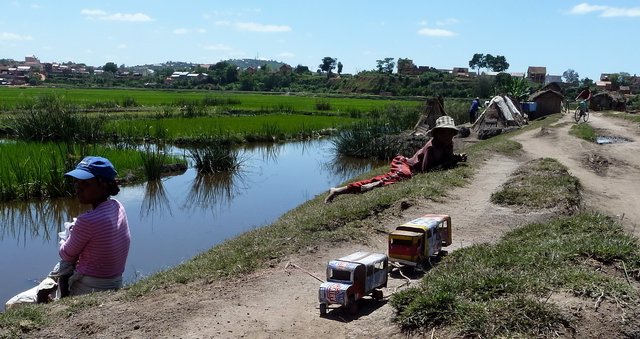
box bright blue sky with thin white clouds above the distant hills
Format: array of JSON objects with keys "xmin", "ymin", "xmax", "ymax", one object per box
[{"xmin": 0, "ymin": 0, "xmax": 640, "ymax": 79}]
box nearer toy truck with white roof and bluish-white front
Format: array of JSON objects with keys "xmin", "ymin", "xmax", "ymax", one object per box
[{"xmin": 318, "ymin": 252, "xmax": 389, "ymax": 316}]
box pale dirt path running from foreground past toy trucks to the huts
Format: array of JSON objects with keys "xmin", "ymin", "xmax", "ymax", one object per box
[{"xmin": 34, "ymin": 114, "xmax": 640, "ymax": 338}]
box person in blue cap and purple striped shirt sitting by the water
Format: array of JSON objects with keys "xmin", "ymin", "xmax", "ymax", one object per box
[{"xmin": 54, "ymin": 156, "xmax": 131, "ymax": 296}]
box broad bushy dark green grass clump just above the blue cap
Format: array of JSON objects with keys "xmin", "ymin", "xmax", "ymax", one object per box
[{"xmin": 11, "ymin": 94, "xmax": 104, "ymax": 142}]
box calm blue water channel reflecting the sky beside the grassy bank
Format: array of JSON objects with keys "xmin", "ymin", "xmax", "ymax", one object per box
[{"xmin": 0, "ymin": 139, "xmax": 382, "ymax": 304}]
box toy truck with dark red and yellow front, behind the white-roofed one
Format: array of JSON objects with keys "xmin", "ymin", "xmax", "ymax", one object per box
[{"xmin": 389, "ymin": 214, "xmax": 451, "ymax": 268}]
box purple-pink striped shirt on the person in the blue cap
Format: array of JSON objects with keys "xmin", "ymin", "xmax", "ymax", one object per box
[{"xmin": 59, "ymin": 199, "xmax": 131, "ymax": 278}]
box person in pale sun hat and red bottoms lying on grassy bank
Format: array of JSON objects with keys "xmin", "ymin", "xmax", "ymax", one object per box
[{"xmin": 324, "ymin": 115, "xmax": 467, "ymax": 203}]
